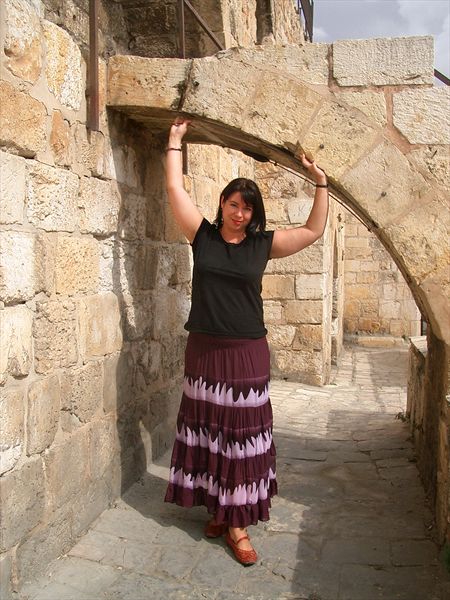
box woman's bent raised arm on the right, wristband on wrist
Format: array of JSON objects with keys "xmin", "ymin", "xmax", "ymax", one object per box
[{"xmin": 270, "ymin": 154, "xmax": 329, "ymax": 258}]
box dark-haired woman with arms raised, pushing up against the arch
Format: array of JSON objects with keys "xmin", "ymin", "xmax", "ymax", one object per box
[{"xmin": 165, "ymin": 119, "xmax": 328, "ymax": 565}]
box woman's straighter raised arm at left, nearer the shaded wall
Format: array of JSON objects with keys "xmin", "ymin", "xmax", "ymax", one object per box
[{"xmin": 166, "ymin": 119, "xmax": 203, "ymax": 243}]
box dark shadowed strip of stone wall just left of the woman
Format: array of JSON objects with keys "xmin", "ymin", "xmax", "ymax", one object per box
[{"xmin": 107, "ymin": 110, "xmax": 190, "ymax": 493}]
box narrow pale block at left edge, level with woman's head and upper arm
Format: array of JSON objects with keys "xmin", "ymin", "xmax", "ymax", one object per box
[{"xmin": 0, "ymin": 152, "xmax": 26, "ymax": 224}]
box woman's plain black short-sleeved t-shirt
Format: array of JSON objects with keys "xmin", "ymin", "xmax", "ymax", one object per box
[{"xmin": 185, "ymin": 219, "xmax": 274, "ymax": 338}]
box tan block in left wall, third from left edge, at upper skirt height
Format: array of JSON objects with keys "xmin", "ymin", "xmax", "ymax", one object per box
[{"xmin": 61, "ymin": 361, "xmax": 103, "ymax": 431}]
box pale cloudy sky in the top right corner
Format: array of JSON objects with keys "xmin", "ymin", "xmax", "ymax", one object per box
[{"xmin": 313, "ymin": 0, "xmax": 450, "ymax": 77}]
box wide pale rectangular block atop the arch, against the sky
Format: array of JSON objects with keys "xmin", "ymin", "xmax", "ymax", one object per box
[{"xmin": 333, "ymin": 36, "xmax": 434, "ymax": 86}]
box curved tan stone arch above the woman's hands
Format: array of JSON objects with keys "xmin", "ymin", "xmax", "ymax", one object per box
[{"xmin": 107, "ymin": 46, "xmax": 450, "ymax": 344}]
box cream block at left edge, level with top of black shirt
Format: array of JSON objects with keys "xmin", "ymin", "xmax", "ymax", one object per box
[{"xmin": 0, "ymin": 231, "xmax": 36, "ymax": 302}]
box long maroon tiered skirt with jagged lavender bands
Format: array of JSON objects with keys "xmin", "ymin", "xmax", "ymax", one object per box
[{"xmin": 165, "ymin": 333, "xmax": 277, "ymax": 527}]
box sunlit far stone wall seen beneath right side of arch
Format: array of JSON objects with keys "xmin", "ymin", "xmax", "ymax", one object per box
[{"xmin": 343, "ymin": 209, "xmax": 420, "ymax": 342}]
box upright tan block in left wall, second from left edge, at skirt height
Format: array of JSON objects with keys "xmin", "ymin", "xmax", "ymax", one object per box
[{"xmin": 27, "ymin": 375, "xmax": 61, "ymax": 456}]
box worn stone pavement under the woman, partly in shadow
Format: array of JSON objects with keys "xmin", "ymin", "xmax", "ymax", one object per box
[{"xmin": 21, "ymin": 346, "xmax": 450, "ymax": 600}]
